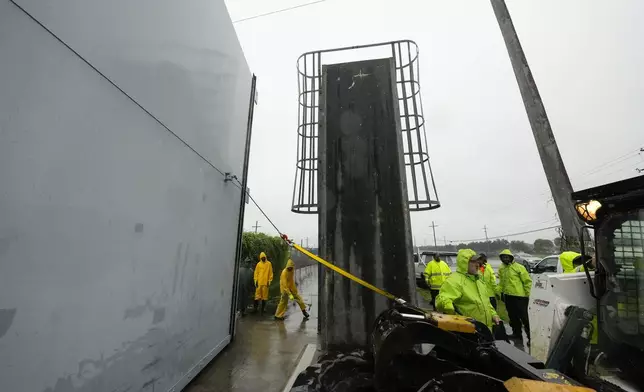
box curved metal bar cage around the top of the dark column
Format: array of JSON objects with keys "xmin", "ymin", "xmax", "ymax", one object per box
[{"xmin": 291, "ymin": 40, "xmax": 440, "ymax": 214}]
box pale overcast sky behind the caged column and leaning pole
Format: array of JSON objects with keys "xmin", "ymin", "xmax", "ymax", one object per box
[{"xmin": 226, "ymin": 0, "xmax": 644, "ymax": 245}]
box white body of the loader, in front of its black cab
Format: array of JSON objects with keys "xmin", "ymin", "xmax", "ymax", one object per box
[{"xmin": 528, "ymin": 272, "xmax": 595, "ymax": 362}]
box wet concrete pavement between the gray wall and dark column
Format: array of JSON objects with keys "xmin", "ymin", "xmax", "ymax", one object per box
[{"xmin": 184, "ymin": 266, "xmax": 318, "ymax": 392}]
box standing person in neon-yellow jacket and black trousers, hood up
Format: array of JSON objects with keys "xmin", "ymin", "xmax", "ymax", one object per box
[{"xmin": 497, "ymin": 249, "xmax": 532, "ymax": 345}]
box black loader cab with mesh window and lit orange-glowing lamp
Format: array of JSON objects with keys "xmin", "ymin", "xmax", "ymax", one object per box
[{"xmin": 572, "ymin": 176, "xmax": 644, "ymax": 372}]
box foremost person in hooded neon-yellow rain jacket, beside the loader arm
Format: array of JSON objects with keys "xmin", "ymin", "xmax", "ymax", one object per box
[{"xmin": 436, "ymin": 249, "xmax": 501, "ymax": 330}]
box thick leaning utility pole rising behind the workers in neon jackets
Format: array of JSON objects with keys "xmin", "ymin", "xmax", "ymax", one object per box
[{"xmin": 490, "ymin": 0, "xmax": 581, "ymax": 240}]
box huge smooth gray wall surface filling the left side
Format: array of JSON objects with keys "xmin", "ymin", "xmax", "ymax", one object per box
[{"xmin": 0, "ymin": 0, "xmax": 251, "ymax": 392}]
